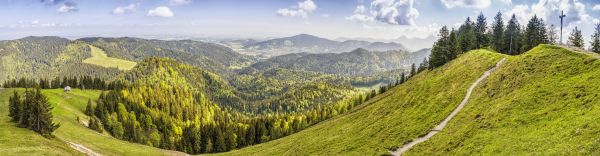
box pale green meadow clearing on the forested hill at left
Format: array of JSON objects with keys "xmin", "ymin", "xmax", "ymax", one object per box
[{"xmin": 83, "ymin": 45, "xmax": 136, "ymax": 70}]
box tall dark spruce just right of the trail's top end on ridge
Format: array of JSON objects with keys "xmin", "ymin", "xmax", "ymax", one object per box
[{"xmin": 503, "ymin": 14, "xmax": 521, "ymax": 55}]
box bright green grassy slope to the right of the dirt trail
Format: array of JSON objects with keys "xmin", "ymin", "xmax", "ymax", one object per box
[{"xmin": 407, "ymin": 45, "xmax": 600, "ymax": 155}]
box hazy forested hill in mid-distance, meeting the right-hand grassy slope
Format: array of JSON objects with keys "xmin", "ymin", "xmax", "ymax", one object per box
[{"xmin": 250, "ymin": 49, "xmax": 430, "ymax": 76}]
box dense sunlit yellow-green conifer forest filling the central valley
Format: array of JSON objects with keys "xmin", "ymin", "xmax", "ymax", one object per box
[{"xmin": 86, "ymin": 58, "xmax": 394, "ymax": 153}]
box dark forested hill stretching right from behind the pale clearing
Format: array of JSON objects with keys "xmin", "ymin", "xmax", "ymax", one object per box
[{"xmin": 79, "ymin": 37, "xmax": 254, "ymax": 75}]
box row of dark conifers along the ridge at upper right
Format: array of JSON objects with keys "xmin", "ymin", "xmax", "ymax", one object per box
[{"xmin": 421, "ymin": 12, "xmax": 600, "ymax": 69}]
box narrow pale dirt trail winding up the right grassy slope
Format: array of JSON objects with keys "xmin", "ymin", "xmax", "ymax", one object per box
[{"xmin": 391, "ymin": 58, "xmax": 506, "ymax": 156}]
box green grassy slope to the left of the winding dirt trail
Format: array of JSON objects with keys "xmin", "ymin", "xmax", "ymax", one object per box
[{"xmin": 223, "ymin": 51, "xmax": 503, "ymax": 155}]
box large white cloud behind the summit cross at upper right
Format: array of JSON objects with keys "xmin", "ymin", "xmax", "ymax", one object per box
[{"xmin": 506, "ymin": 0, "xmax": 595, "ymax": 26}]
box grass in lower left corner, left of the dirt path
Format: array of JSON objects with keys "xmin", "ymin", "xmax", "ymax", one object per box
[{"xmin": 0, "ymin": 90, "xmax": 82, "ymax": 155}]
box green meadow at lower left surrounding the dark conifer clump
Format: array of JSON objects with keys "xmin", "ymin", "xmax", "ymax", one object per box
[{"xmin": 0, "ymin": 89, "xmax": 182, "ymax": 155}]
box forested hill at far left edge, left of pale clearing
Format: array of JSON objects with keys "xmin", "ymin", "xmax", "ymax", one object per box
[{"xmin": 0, "ymin": 37, "xmax": 119, "ymax": 81}]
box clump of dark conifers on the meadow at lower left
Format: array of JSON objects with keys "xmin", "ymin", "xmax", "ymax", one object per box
[{"xmin": 8, "ymin": 88, "xmax": 60, "ymax": 137}]
